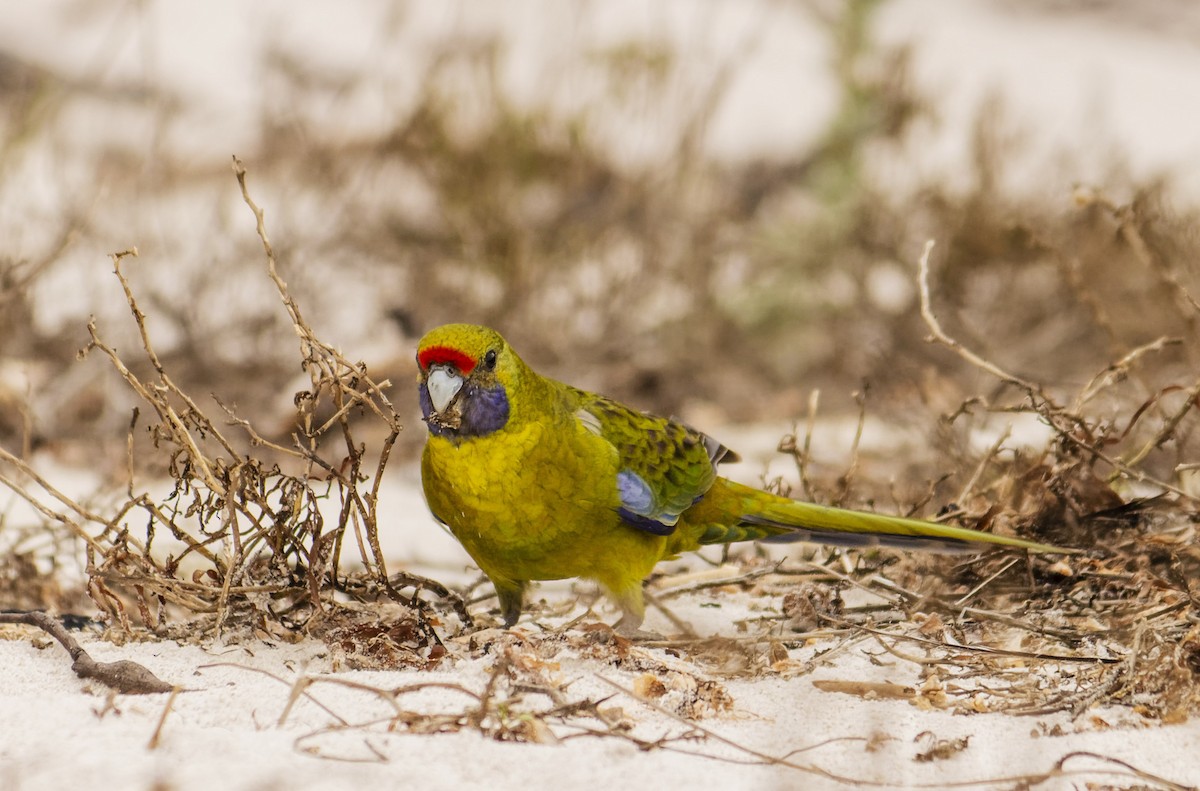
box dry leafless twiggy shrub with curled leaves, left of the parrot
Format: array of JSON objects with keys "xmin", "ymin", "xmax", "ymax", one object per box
[{"xmin": 0, "ymin": 160, "xmax": 468, "ymax": 666}]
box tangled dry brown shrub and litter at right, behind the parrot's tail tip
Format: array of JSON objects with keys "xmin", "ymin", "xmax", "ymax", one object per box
[{"xmin": 763, "ymin": 240, "xmax": 1200, "ymax": 726}]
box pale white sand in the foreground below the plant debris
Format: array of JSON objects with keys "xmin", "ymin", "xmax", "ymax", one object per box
[{"xmin": 0, "ymin": 640, "xmax": 1200, "ymax": 791}]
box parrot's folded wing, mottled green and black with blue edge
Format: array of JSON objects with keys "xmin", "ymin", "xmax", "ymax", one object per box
[{"xmin": 575, "ymin": 390, "xmax": 737, "ymax": 535}]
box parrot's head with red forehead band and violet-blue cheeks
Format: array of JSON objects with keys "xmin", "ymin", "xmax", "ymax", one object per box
[{"xmin": 416, "ymin": 324, "xmax": 522, "ymax": 437}]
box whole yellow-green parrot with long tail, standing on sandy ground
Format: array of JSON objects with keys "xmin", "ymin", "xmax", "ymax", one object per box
[{"xmin": 416, "ymin": 324, "xmax": 1069, "ymax": 635}]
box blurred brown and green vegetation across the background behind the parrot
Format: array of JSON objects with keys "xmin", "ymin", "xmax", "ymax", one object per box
[{"xmin": 0, "ymin": 0, "xmax": 1200, "ymax": 482}]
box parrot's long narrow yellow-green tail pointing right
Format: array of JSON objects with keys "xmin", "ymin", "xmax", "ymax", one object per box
[{"xmin": 694, "ymin": 479, "xmax": 1078, "ymax": 555}]
